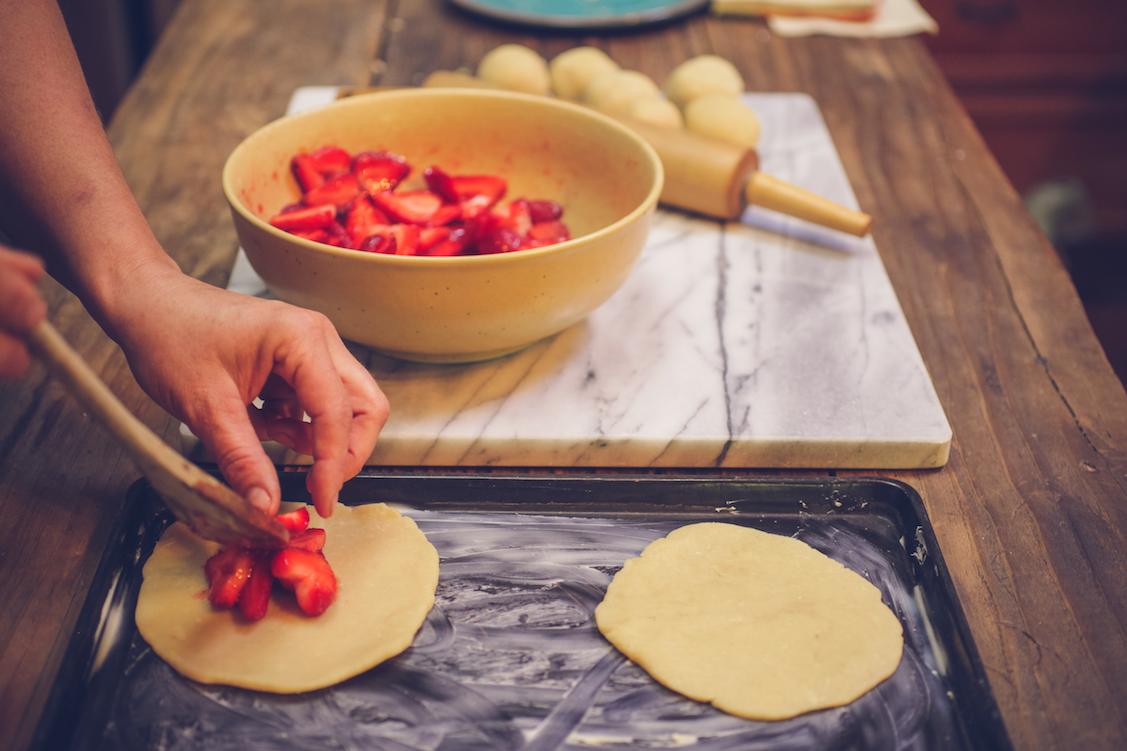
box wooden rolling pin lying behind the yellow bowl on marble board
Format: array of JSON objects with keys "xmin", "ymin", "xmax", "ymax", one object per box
[{"xmin": 423, "ymin": 71, "xmax": 872, "ymax": 237}]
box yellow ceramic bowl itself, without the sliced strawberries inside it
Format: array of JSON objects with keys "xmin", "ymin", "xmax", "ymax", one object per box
[{"xmin": 223, "ymin": 89, "xmax": 662, "ymax": 362}]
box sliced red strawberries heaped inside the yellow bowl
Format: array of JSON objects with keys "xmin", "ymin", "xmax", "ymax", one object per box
[{"xmin": 270, "ymin": 145, "xmax": 571, "ymax": 256}]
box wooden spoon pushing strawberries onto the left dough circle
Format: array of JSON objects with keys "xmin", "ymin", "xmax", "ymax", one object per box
[{"xmin": 28, "ymin": 321, "xmax": 290, "ymax": 548}]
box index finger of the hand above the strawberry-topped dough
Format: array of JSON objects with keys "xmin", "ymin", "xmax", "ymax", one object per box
[{"xmin": 267, "ymin": 311, "xmax": 352, "ymax": 516}]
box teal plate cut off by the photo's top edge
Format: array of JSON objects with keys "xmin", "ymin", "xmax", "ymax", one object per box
[{"xmin": 451, "ymin": 0, "xmax": 708, "ymax": 28}]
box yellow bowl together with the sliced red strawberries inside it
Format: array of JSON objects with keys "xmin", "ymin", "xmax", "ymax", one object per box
[{"xmin": 223, "ymin": 89, "xmax": 663, "ymax": 362}]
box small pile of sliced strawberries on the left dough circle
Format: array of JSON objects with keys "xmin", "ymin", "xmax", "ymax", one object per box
[{"xmin": 204, "ymin": 506, "xmax": 337, "ymax": 621}]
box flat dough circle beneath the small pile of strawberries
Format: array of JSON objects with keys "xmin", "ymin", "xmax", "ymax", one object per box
[{"xmin": 136, "ymin": 503, "xmax": 438, "ymax": 693}]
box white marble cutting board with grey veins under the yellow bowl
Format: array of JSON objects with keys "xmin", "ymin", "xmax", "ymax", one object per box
[{"xmin": 213, "ymin": 87, "xmax": 951, "ymax": 469}]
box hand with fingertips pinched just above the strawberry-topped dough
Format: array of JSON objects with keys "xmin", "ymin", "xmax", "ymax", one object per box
[{"xmin": 107, "ymin": 268, "xmax": 388, "ymax": 516}]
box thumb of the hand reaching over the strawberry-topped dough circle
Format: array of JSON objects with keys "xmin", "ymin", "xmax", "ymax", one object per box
[{"xmin": 188, "ymin": 398, "xmax": 282, "ymax": 515}]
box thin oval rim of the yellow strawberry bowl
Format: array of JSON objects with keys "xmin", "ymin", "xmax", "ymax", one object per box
[{"xmin": 222, "ymin": 87, "xmax": 665, "ymax": 266}]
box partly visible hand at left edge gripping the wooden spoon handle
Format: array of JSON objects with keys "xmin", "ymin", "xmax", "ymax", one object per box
[{"xmin": 0, "ymin": 245, "xmax": 47, "ymax": 378}]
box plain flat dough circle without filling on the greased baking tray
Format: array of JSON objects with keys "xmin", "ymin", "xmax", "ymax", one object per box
[{"xmin": 595, "ymin": 522, "xmax": 904, "ymax": 719}]
